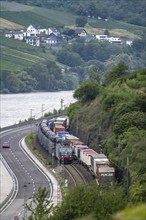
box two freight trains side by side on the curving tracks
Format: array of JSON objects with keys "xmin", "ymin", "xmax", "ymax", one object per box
[{"xmin": 38, "ymin": 116, "xmax": 115, "ymax": 185}]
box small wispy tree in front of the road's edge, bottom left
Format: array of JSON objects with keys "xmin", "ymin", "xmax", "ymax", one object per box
[{"xmin": 26, "ymin": 188, "xmax": 53, "ymax": 220}]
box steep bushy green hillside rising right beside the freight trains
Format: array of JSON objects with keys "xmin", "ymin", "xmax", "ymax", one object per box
[{"xmin": 68, "ymin": 63, "xmax": 146, "ymax": 201}]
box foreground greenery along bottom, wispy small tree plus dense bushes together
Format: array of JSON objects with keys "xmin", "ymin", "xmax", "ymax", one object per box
[{"xmin": 26, "ymin": 184, "xmax": 127, "ymax": 220}]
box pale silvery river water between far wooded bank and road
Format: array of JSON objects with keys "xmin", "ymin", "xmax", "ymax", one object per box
[{"xmin": 0, "ymin": 91, "xmax": 75, "ymax": 128}]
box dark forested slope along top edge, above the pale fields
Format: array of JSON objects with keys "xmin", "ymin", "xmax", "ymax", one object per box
[{"xmin": 1, "ymin": 0, "xmax": 146, "ymax": 26}]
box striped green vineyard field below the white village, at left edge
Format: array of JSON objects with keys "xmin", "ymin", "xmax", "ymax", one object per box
[{"xmin": 0, "ymin": 36, "xmax": 54, "ymax": 71}]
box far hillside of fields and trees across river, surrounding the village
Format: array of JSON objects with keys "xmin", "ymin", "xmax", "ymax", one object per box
[{"xmin": 0, "ymin": 1, "xmax": 145, "ymax": 93}]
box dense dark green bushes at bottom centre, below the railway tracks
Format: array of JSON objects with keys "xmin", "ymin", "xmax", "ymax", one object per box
[{"xmin": 49, "ymin": 185, "xmax": 126, "ymax": 220}]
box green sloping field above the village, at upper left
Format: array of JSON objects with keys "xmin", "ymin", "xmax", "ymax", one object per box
[{"xmin": 1, "ymin": 1, "xmax": 76, "ymax": 27}]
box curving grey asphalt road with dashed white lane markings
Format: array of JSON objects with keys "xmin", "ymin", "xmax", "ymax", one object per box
[{"xmin": 0, "ymin": 125, "xmax": 55, "ymax": 220}]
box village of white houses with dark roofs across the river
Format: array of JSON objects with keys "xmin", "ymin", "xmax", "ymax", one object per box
[{"xmin": 3, "ymin": 24, "xmax": 133, "ymax": 47}]
